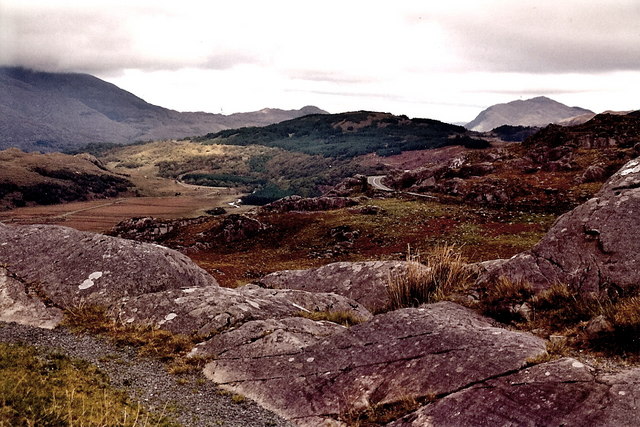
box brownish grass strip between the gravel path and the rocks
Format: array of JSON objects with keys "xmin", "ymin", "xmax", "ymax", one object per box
[{"xmin": 64, "ymin": 304, "xmax": 208, "ymax": 374}]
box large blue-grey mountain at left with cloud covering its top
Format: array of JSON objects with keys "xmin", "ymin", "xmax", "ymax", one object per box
[{"xmin": 0, "ymin": 67, "xmax": 325, "ymax": 152}]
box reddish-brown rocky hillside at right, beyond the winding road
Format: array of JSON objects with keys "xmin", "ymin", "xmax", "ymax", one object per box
[{"xmin": 387, "ymin": 112, "xmax": 640, "ymax": 213}]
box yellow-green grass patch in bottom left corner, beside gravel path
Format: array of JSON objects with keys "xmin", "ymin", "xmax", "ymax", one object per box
[{"xmin": 0, "ymin": 343, "xmax": 177, "ymax": 426}]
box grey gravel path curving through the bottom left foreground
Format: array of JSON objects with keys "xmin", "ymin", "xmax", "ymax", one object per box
[{"xmin": 0, "ymin": 322, "xmax": 291, "ymax": 427}]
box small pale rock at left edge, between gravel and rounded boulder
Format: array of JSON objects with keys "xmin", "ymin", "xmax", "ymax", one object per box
[{"xmin": 0, "ymin": 267, "xmax": 62, "ymax": 329}]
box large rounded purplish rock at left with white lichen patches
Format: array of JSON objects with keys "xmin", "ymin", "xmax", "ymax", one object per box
[{"xmin": 0, "ymin": 224, "xmax": 217, "ymax": 308}]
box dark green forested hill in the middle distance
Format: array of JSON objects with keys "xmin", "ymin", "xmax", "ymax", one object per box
[{"xmin": 194, "ymin": 111, "xmax": 488, "ymax": 158}]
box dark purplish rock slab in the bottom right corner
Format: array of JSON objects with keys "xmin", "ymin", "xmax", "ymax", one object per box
[{"xmin": 391, "ymin": 358, "xmax": 640, "ymax": 427}]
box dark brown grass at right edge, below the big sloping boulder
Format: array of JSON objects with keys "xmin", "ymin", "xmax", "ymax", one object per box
[{"xmin": 479, "ymin": 278, "xmax": 640, "ymax": 363}]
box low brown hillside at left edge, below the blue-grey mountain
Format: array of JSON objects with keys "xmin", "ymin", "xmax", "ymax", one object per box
[{"xmin": 0, "ymin": 148, "xmax": 133, "ymax": 210}]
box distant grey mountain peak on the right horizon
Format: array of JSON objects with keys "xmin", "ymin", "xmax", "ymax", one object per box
[{"xmin": 465, "ymin": 96, "xmax": 593, "ymax": 132}]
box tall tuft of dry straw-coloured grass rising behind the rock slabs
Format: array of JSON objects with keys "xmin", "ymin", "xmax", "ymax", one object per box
[{"xmin": 387, "ymin": 245, "xmax": 471, "ymax": 310}]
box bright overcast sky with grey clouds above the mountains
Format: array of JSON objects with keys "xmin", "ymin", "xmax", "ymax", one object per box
[{"xmin": 0, "ymin": 0, "xmax": 640, "ymax": 122}]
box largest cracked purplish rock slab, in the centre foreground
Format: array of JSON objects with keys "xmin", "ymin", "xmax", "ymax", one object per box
[{"xmin": 205, "ymin": 302, "xmax": 545, "ymax": 425}]
